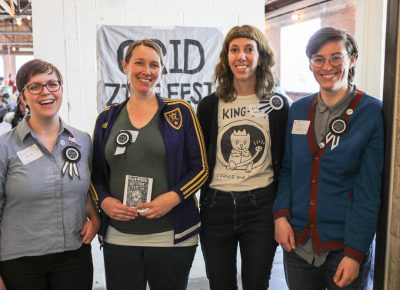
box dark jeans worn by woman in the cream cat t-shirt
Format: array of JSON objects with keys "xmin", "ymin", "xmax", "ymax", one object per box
[{"xmin": 200, "ymin": 185, "xmax": 277, "ymax": 290}]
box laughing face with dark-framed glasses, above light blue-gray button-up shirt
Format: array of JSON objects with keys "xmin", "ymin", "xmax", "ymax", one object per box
[{"xmin": 21, "ymin": 72, "xmax": 62, "ymax": 120}]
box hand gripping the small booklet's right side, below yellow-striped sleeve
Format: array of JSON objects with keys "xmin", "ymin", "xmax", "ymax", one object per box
[{"xmin": 137, "ymin": 191, "xmax": 181, "ymax": 219}]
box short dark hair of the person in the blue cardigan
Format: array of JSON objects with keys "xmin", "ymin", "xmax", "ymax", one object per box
[{"xmin": 306, "ymin": 27, "xmax": 358, "ymax": 83}]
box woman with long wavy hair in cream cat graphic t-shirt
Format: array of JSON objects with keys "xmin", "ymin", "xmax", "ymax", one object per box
[{"xmin": 197, "ymin": 25, "xmax": 289, "ymax": 290}]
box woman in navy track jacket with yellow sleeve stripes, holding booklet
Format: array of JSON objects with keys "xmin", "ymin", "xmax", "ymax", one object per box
[{"xmin": 92, "ymin": 40, "xmax": 208, "ymax": 290}]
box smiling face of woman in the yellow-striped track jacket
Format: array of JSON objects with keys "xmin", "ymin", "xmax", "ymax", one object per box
[{"xmin": 123, "ymin": 45, "xmax": 161, "ymax": 96}]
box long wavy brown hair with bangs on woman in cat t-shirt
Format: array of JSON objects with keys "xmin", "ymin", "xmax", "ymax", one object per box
[{"xmin": 214, "ymin": 25, "xmax": 275, "ymax": 102}]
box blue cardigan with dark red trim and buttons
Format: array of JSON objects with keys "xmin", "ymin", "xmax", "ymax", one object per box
[{"xmin": 273, "ymin": 92, "xmax": 384, "ymax": 262}]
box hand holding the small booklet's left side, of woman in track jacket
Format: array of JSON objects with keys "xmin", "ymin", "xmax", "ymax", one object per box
[{"xmin": 101, "ymin": 197, "xmax": 138, "ymax": 221}]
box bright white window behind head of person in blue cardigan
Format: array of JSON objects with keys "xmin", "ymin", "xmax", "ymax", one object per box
[{"xmin": 281, "ymin": 18, "xmax": 321, "ymax": 93}]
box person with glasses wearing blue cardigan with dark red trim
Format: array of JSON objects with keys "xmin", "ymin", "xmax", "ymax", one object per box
[{"xmin": 274, "ymin": 27, "xmax": 383, "ymax": 290}]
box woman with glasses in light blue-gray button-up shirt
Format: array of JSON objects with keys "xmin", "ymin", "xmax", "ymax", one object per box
[{"xmin": 0, "ymin": 59, "xmax": 100, "ymax": 290}]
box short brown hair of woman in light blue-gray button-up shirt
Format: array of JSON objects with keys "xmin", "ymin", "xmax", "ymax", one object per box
[{"xmin": 15, "ymin": 59, "xmax": 63, "ymax": 92}]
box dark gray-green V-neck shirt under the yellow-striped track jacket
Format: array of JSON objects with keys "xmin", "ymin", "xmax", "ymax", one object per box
[{"xmin": 105, "ymin": 106, "xmax": 173, "ymax": 234}]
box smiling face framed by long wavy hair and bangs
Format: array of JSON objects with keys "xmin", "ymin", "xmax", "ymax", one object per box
[{"xmin": 228, "ymin": 38, "xmax": 259, "ymax": 86}]
